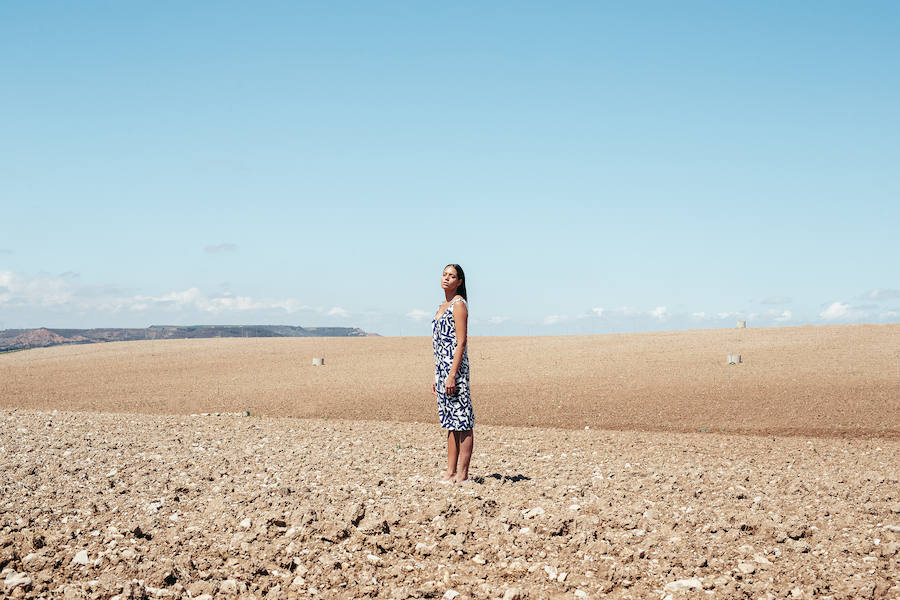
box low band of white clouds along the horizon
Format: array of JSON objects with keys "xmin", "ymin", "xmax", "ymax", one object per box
[{"xmin": 0, "ymin": 270, "xmax": 900, "ymax": 335}]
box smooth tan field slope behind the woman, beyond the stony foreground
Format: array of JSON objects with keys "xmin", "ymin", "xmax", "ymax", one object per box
[{"xmin": 0, "ymin": 325, "xmax": 900, "ymax": 439}]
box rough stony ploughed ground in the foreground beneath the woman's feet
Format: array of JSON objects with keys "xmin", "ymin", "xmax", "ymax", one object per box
[{"xmin": 0, "ymin": 410, "xmax": 900, "ymax": 600}]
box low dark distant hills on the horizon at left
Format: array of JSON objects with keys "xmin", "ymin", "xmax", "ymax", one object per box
[{"xmin": 0, "ymin": 325, "xmax": 377, "ymax": 352}]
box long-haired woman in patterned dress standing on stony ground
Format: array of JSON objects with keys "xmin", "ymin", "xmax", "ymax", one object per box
[{"xmin": 431, "ymin": 264, "xmax": 475, "ymax": 483}]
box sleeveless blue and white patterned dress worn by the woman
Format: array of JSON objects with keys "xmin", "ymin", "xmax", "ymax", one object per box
[{"xmin": 431, "ymin": 298, "xmax": 475, "ymax": 431}]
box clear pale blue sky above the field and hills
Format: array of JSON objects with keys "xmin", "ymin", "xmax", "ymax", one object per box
[{"xmin": 0, "ymin": 2, "xmax": 900, "ymax": 335}]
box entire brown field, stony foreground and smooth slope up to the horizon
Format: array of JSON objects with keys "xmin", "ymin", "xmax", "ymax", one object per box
[{"xmin": 0, "ymin": 326, "xmax": 900, "ymax": 600}]
